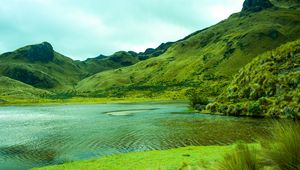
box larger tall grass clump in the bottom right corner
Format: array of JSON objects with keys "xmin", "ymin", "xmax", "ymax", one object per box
[{"xmin": 265, "ymin": 122, "xmax": 300, "ymax": 170}]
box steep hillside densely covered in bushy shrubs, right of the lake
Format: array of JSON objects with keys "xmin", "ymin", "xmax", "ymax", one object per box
[{"xmin": 206, "ymin": 40, "xmax": 300, "ymax": 118}]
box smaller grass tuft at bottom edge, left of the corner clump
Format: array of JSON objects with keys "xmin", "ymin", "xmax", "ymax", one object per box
[{"xmin": 216, "ymin": 144, "xmax": 260, "ymax": 170}]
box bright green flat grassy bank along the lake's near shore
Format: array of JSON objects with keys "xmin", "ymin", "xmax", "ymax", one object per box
[{"xmin": 32, "ymin": 145, "xmax": 244, "ymax": 170}]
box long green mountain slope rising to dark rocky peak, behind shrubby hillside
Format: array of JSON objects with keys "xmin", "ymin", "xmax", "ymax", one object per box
[{"xmin": 76, "ymin": 0, "xmax": 300, "ymax": 98}]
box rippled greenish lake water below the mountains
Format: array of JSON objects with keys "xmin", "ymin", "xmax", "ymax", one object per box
[{"xmin": 0, "ymin": 103, "xmax": 268, "ymax": 169}]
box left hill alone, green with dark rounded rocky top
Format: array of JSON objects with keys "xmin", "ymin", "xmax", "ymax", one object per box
[{"xmin": 0, "ymin": 42, "xmax": 86, "ymax": 89}]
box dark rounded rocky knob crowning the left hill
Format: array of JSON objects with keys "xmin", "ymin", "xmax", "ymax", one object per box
[{"xmin": 17, "ymin": 42, "xmax": 54, "ymax": 62}]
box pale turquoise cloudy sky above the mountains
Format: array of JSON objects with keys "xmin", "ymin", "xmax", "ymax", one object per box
[{"xmin": 0, "ymin": 0, "xmax": 244, "ymax": 60}]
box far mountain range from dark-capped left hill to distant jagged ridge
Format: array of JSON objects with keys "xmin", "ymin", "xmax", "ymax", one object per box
[{"xmin": 0, "ymin": 42, "xmax": 172, "ymax": 91}]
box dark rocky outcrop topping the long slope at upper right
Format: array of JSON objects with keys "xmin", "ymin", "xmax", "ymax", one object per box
[{"xmin": 242, "ymin": 0, "xmax": 273, "ymax": 11}]
